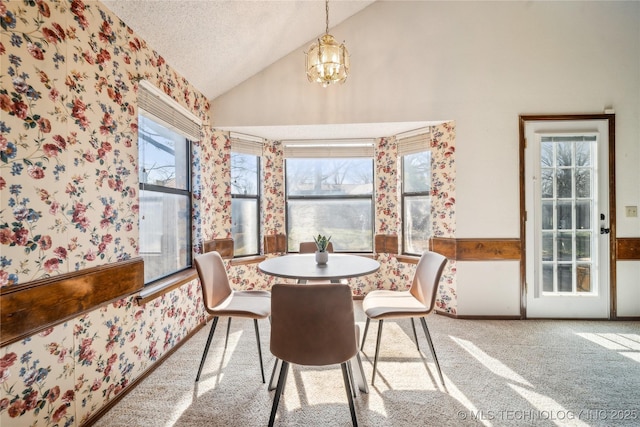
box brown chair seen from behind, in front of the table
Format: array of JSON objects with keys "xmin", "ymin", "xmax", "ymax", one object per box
[{"xmin": 269, "ymin": 284, "xmax": 359, "ymax": 426}]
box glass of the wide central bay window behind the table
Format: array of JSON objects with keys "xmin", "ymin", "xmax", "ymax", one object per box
[{"xmin": 285, "ymin": 158, "xmax": 373, "ymax": 252}]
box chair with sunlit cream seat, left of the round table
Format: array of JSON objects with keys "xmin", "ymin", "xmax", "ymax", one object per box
[{"xmin": 195, "ymin": 251, "xmax": 271, "ymax": 383}]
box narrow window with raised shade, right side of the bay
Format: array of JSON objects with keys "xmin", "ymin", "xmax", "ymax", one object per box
[{"xmin": 398, "ymin": 130, "xmax": 431, "ymax": 255}]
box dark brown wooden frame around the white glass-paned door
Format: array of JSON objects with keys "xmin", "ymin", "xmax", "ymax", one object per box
[{"xmin": 519, "ymin": 114, "xmax": 617, "ymax": 319}]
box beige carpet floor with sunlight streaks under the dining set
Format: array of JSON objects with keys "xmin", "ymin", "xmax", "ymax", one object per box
[{"xmin": 95, "ymin": 302, "xmax": 640, "ymax": 427}]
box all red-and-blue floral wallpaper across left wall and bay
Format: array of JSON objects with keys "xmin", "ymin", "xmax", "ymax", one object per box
[{"xmin": 0, "ymin": 0, "xmax": 455, "ymax": 426}]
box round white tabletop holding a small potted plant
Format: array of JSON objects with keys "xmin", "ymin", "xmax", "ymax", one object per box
[{"xmin": 258, "ymin": 253, "xmax": 380, "ymax": 281}]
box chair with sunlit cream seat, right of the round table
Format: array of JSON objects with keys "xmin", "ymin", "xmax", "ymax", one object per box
[{"xmin": 360, "ymin": 251, "xmax": 447, "ymax": 385}]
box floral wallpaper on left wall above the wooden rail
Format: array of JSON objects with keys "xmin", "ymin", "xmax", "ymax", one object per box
[{"xmin": 0, "ymin": 0, "xmax": 209, "ymax": 286}]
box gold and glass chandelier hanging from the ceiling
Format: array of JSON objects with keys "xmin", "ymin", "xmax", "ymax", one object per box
[{"xmin": 305, "ymin": 0, "xmax": 349, "ymax": 87}]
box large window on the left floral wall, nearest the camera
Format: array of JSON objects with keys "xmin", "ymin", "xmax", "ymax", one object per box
[{"xmin": 138, "ymin": 84, "xmax": 199, "ymax": 284}]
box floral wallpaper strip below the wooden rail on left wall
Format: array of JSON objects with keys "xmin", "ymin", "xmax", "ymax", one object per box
[{"xmin": 0, "ymin": 282, "xmax": 204, "ymax": 426}]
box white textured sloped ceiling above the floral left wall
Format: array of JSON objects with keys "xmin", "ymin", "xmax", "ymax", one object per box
[{"xmin": 102, "ymin": 0, "xmax": 373, "ymax": 99}]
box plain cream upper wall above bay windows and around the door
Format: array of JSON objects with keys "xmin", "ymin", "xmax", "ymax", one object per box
[{"xmin": 212, "ymin": 1, "xmax": 640, "ymax": 315}]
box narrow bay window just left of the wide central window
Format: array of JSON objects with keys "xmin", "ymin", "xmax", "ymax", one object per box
[{"xmin": 231, "ymin": 146, "xmax": 260, "ymax": 256}]
